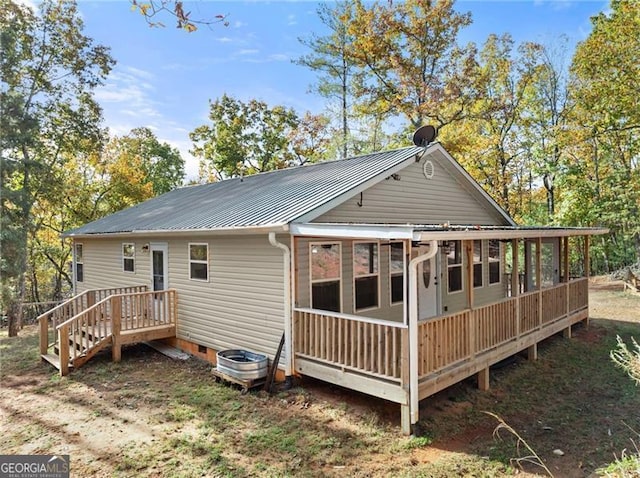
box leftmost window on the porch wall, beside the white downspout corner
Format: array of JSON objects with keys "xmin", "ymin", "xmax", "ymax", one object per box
[{"xmin": 309, "ymin": 243, "xmax": 342, "ymax": 312}]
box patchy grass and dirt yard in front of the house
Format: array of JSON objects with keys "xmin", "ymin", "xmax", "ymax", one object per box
[{"xmin": 0, "ymin": 278, "xmax": 640, "ymax": 478}]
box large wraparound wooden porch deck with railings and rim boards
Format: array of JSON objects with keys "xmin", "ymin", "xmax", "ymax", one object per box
[{"xmin": 294, "ymin": 278, "xmax": 588, "ymax": 428}]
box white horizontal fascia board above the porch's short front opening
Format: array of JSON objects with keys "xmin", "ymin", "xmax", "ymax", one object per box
[{"xmin": 290, "ymin": 223, "xmax": 415, "ymax": 239}]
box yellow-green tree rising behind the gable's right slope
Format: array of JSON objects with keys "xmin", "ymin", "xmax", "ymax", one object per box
[{"xmin": 441, "ymin": 34, "xmax": 540, "ymax": 219}]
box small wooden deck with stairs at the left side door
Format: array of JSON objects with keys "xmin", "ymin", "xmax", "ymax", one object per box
[{"xmin": 38, "ymin": 286, "xmax": 177, "ymax": 375}]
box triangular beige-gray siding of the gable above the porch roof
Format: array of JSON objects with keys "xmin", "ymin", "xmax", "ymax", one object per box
[{"xmin": 314, "ymin": 152, "xmax": 506, "ymax": 225}]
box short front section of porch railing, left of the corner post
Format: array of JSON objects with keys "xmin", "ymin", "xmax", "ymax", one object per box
[{"xmin": 294, "ymin": 309, "xmax": 407, "ymax": 382}]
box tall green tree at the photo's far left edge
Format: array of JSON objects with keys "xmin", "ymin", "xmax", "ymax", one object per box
[{"xmin": 0, "ymin": 0, "xmax": 113, "ymax": 334}]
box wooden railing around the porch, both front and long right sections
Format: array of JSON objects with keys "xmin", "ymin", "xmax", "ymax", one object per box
[{"xmin": 294, "ymin": 278, "xmax": 588, "ymax": 390}]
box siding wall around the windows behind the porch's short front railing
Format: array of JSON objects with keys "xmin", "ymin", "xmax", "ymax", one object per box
[{"xmin": 295, "ymin": 238, "xmax": 403, "ymax": 322}]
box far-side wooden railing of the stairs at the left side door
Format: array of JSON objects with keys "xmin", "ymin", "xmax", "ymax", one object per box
[{"xmin": 37, "ymin": 285, "xmax": 147, "ymax": 355}]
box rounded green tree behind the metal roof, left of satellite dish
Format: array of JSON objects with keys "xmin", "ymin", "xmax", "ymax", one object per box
[{"xmin": 190, "ymin": 95, "xmax": 327, "ymax": 180}]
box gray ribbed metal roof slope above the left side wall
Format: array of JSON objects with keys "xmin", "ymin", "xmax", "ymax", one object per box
[{"xmin": 65, "ymin": 146, "xmax": 424, "ymax": 236}]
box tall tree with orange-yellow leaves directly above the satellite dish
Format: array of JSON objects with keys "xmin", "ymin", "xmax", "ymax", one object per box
[{"xmin": 343, "ymin": 0, "xmax": 476, "ymax": 129}]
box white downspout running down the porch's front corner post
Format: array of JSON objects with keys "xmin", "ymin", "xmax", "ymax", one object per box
[{"xmin": 408, "ymin": 241, "xmax": 438, "ymax": 432}]
